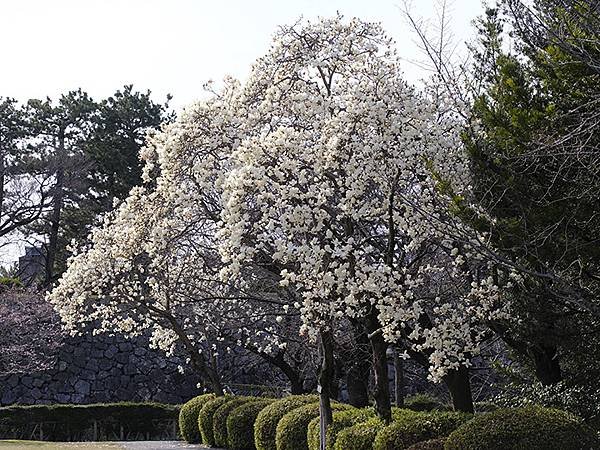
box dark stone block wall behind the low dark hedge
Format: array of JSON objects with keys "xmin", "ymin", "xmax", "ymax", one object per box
[{"xmin": 0, "ymin": 335, "xmax": 199, "ymax": 406}]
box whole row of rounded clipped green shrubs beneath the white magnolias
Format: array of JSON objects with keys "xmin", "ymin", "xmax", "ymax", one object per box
[{"xmin": 180, "ymin": 396, "xmax": 600, "ymax": 450}]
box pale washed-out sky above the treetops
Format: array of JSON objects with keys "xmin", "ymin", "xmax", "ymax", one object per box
[{"xmin": 0, "ymin": 0, "xmax": 482, "ymax": 109}]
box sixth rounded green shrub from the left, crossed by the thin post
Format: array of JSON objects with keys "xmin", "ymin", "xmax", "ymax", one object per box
[{"xmin": 275, "ymin": 403, "xmax": 352, "ymax": 450}]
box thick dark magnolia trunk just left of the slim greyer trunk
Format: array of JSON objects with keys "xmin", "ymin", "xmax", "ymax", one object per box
[{"xmin": 366, "ymin": 308, "xmax": 392, "ymax": 423}]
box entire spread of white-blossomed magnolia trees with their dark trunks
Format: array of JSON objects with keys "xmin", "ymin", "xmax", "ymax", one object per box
[{"xmin": 50, "ymin": 17, "xmax": 516, "ymax": 422}]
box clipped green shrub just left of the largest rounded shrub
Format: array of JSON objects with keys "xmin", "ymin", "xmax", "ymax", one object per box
[{"xmin": 373, "ymin": 412, "xmax": 472, "ymax": 450}]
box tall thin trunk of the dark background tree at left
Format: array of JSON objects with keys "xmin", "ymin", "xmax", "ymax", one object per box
[{"xmin": 44, "ymin": 129, "xmax": 66, "ymax": 285}]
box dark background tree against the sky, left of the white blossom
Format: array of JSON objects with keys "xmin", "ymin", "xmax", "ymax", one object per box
[{"xmin": 18, "ymin": 85, "xmax": 172, "ymax": 282}]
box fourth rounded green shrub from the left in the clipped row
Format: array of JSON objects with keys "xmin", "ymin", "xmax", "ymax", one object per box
[{"xmin": 227, "ymin": 399, "xmax": 273, "ymax": 450}]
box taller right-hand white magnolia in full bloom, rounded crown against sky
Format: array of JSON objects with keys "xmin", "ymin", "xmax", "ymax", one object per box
[{"xmin": 221, "ymin": 17, "xmax": 510, "ymax": 420}]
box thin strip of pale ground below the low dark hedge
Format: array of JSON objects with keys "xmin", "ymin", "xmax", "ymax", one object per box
[{"xmin": 0, "ymin": 441, "xmax": 217, "ymax": 450}]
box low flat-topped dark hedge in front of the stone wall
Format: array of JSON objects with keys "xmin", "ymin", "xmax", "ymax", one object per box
[{"xmin": 0, "ymin": 403, "xmax": 179, "ymax": 441}]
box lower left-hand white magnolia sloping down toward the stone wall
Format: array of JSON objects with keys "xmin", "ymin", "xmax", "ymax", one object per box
[{"xmin": 50, "ymin": 83, "xmax": 318, "ymax": 393}]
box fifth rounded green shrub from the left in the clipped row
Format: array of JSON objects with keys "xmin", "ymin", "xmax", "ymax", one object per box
[{"xmin": 254, "ymin": 395, "xmax": 319, "ymax": 450}]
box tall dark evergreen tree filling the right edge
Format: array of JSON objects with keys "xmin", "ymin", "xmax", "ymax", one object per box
[{"xmin": 464, "ymin": 0, "xmax": 600, "ymax": 392}]
